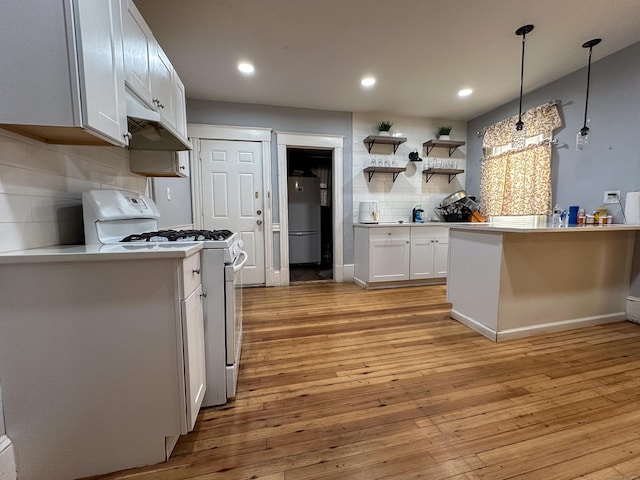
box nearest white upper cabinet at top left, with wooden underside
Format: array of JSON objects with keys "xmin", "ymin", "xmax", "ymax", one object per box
[{"xmin": 0, "ymin": 0, "xmax": 127, "ymax": 146}]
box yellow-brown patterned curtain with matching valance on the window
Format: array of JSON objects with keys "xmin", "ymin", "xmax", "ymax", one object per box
[{"xmin": 480, "ymin": 103, "xmax": 562, "ymax": 216}]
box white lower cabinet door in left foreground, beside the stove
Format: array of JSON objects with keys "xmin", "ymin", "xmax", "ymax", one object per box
[{"xmin": 181, "ymin": 285, "xmax": 206, "ymax": 433}]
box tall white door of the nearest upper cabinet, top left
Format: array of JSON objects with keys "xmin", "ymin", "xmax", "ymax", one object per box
[{"xmin": 74, "ymin": 0, "xmax": 127, "ymax": 145}]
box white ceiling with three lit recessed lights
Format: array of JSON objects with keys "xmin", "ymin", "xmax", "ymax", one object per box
[{"xmin": 135, "ymin": 0, "xmax": 640, "ymax": 121}]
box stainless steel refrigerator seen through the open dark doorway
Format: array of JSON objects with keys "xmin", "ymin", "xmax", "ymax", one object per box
[{"xmin": 288, "ymin": 177, "xmax": 320, "ymax": 264}]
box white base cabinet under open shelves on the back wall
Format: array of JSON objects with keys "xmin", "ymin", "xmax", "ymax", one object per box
[{"xmin": 354, "ymin": 224, "xmax": 449, "ymax": 288}]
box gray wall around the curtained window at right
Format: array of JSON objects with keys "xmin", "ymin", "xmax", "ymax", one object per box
[{"xmin": 466, "ymin": 38, "xmax": 640, "ymax": 296}]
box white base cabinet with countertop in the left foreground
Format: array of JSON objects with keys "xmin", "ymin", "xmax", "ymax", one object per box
[{"xmin": 0, "ymin": 243, "xmax": 206, "ymax": 480}]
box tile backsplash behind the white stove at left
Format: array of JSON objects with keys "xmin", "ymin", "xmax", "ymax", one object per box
[{"xmin": 0, "ymin": 130, "xmax": 147, "ymax": 252}]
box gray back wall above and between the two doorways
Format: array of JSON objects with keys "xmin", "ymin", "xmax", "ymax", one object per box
[{"xmin": 187, "ymin": 99, "xmax": 354, "ymax": 264}]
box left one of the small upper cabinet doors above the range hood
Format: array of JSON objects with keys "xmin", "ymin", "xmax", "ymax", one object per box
[{"xmin": 122, "ymin": 0, "xmax": 155, "ymax": 108}]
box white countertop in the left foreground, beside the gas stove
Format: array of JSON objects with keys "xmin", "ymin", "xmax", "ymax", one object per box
[{"xmin": 0, "ymin": 242, "xmax": 202, "ymax": 264}]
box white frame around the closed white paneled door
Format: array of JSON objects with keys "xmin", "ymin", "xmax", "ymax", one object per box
[{"xmin": 187, "ymin": 123, "xmax": 275, "ymax": 287}]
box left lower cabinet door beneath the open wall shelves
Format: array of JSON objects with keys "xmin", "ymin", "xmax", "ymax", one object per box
[{"xmin": 369, "ymin": 239, "xmax": 410, "ymax": 282}]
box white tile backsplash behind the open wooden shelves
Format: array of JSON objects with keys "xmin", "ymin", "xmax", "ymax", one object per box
[{"xmin": 353, "ymin": 113, "xmax": 467, "ymax": 222}]
